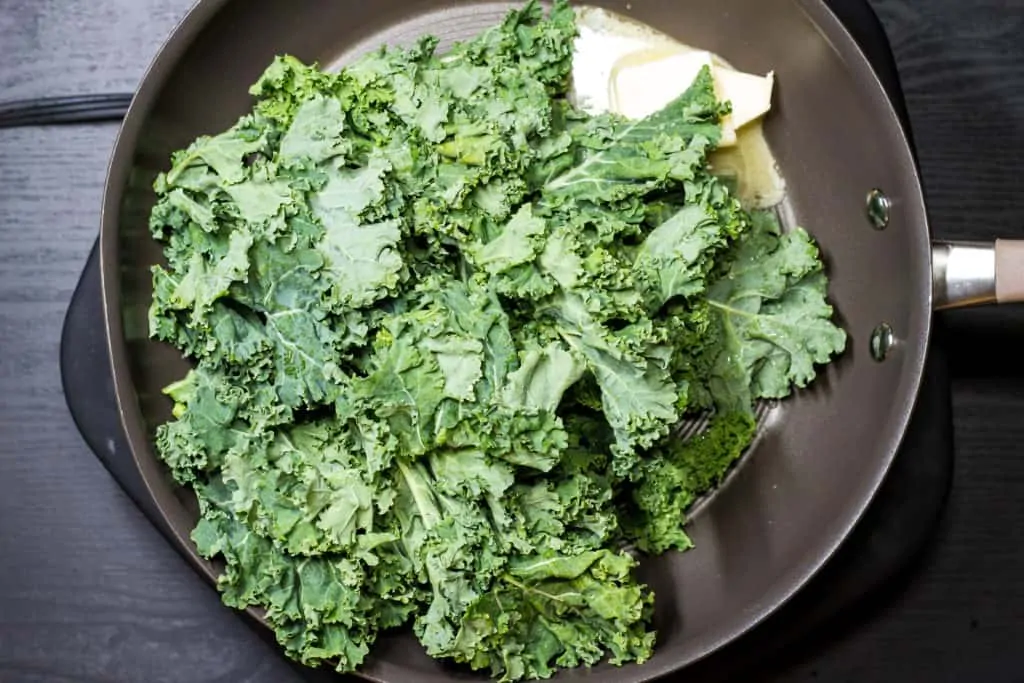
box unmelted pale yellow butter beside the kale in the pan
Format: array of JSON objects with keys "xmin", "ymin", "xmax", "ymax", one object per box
[{"xmin": 608, "ymin": 49, "xmax": 774, "ymax": 146}]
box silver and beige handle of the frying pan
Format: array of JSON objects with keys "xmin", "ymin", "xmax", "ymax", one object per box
[{"xmin": 932, "ymin": 240, "xmax": 1024, "ymax": 310}]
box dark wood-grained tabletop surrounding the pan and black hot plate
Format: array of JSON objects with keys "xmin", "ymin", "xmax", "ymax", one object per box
[{"xmin": 0, "ymin": 0, "xmax": 1024, "ymax": 683}]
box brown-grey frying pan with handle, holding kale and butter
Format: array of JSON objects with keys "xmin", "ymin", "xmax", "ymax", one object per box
[{"xmin": 100, "ymin": 0, "xmax": 1024, "ymax": 683}]
